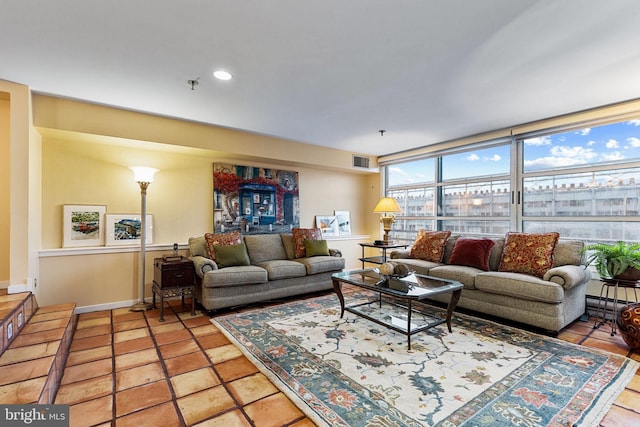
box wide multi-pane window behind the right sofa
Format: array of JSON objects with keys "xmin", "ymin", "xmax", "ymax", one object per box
[{"xmin": 385, "ymin": 119, "xmax": 640, "ymax": 243}]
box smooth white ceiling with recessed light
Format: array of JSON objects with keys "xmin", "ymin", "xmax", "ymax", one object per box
[{"xmin": 0, "ymin": 0, "xmax": 640, "ymax": 155}]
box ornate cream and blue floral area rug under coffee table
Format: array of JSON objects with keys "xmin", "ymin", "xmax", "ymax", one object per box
[{"xmin": 212, "ymin": 293, "xmax": 638, "ymax": 427}]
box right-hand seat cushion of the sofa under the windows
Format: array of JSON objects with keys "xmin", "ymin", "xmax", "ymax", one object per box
[{"xmin": 475, "ymin": 271, "xmax": 564, "ymax": 304}]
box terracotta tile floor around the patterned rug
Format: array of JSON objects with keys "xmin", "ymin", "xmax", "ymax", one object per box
[{"xmin": 50, "ymin": 290, "xmax": 640, "ymax": 427}]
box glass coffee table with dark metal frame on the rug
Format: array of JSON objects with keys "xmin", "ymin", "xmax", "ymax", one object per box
[{"xmin": 331, "ymin": 268, "xmax": 462, "ymax": 350}]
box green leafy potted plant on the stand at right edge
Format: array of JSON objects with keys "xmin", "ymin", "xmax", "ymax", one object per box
[{"xmin": 582, "ymin": 240, "xmax": 640, "ymax": 281}]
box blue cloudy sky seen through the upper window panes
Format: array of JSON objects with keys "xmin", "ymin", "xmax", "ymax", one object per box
[{"xmin": 389, "ymin": 119, "xmax": 640, "ymax": 186}]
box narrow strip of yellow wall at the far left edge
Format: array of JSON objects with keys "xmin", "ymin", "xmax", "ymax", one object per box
[{"xmin": 0, "ymin": 97, "xmax": 11, "ymax": 288}]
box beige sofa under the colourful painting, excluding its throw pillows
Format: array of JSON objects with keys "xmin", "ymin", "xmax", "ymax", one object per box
[{"xmin": 189, "ymin": 234, "xmax": 345, "ymax": 312}]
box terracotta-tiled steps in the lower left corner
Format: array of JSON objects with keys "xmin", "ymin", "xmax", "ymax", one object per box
[{"xmin": 0, "ymin": 293, "xmax": 77, "ymax": 404}]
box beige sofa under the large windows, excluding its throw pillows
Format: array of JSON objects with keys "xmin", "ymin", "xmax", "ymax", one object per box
[{"xmin": 390, "ymin": 235, "xmax": 591, "ymax": 332}]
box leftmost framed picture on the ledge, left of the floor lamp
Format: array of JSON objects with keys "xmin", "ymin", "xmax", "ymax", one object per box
[{"xmin": 62, "ymin": 205, "xmax": 107, "ymax": 248}]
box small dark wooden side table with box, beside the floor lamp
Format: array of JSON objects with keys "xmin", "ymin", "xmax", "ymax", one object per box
[{"xmin": 152, "ymin": 256, "xmax": 196, "ymax": 322}]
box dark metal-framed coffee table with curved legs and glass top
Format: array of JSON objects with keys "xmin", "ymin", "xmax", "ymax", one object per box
[{"xmin": 331, "ymin": 268, "xmax": 462, "ymax": 350}]
